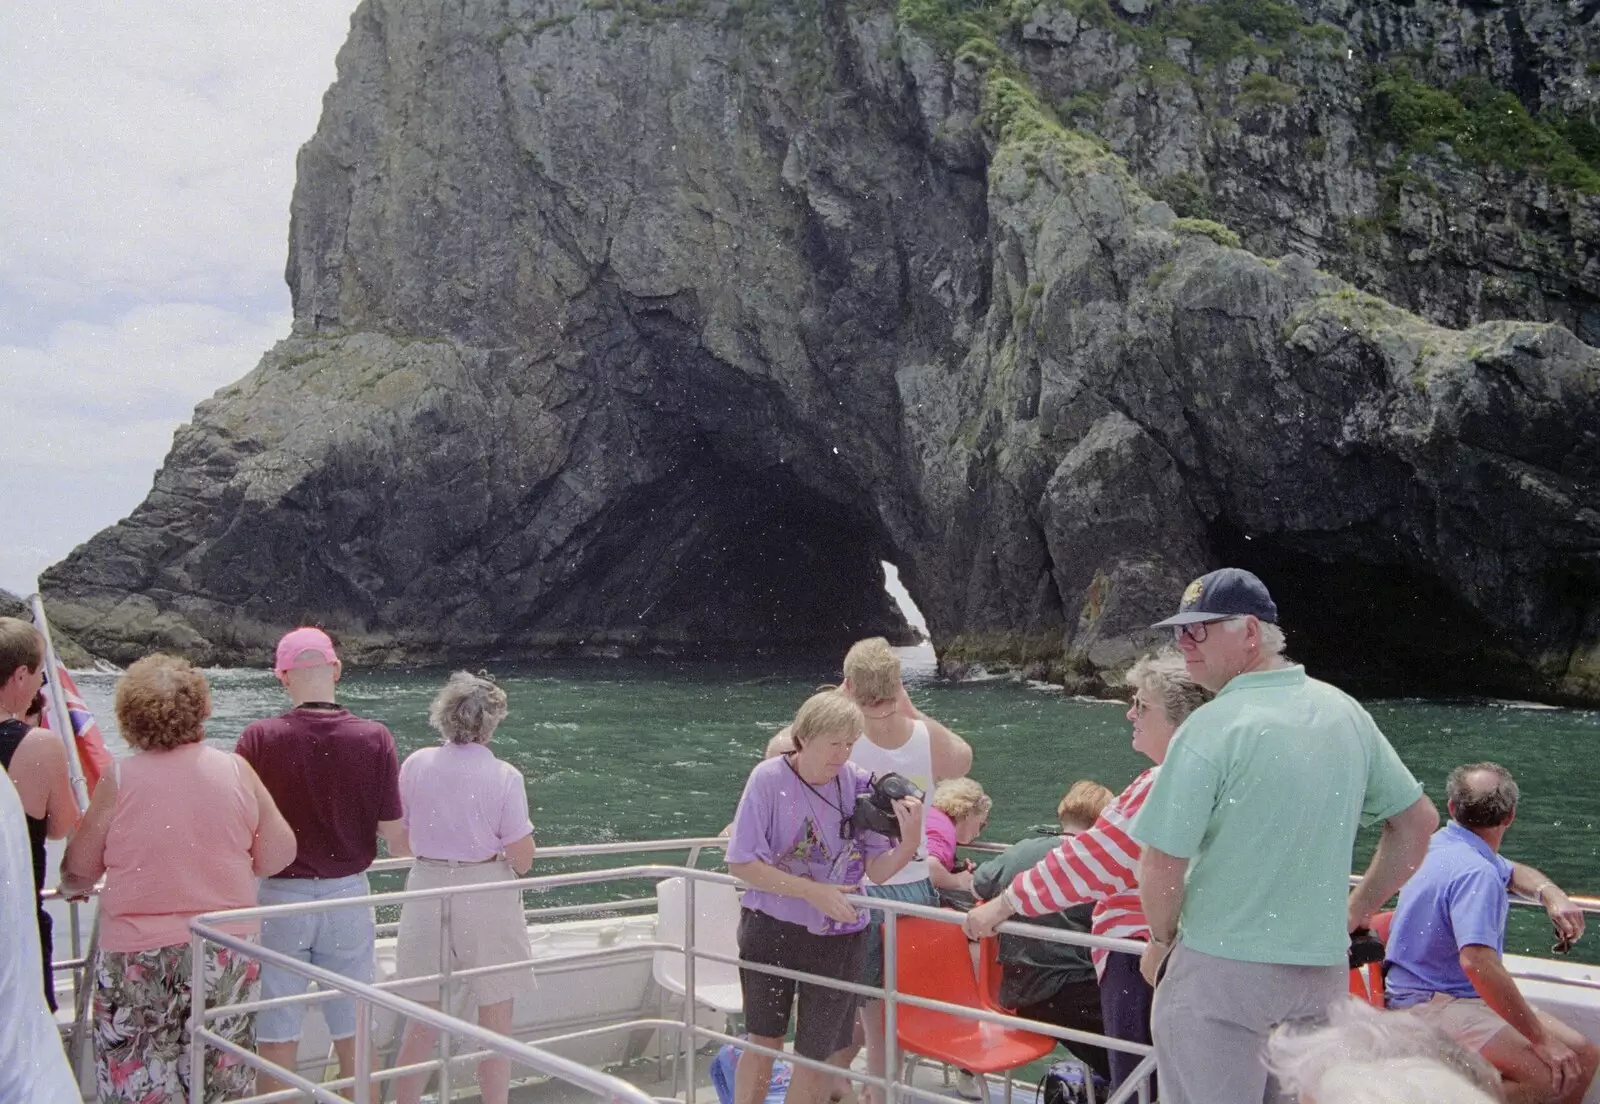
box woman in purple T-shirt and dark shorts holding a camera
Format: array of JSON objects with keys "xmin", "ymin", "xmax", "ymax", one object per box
[{"xmin": 728, "ymin": 690, "xmax": 922, "ymax": 1104}]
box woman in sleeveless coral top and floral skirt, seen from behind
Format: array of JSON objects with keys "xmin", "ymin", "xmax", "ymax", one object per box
[{"xmin": 61, "ymin": 654, "xmax": 294, "ymax": 1104}]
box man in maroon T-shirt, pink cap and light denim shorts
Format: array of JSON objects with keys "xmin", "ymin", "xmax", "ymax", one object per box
[{"xmin": 234, "ymin": 629, "xmax": 410, "ymax": 1093}]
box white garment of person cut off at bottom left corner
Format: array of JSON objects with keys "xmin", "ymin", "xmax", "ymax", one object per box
[{"xmin": 0, "ymin": 770, "xmax": 83, "ymax": 1104}]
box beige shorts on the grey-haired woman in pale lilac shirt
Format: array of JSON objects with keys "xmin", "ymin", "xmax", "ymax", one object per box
[{"xmin": 395, "ymin": 859, "xmax": 534, "ymax": 1005}]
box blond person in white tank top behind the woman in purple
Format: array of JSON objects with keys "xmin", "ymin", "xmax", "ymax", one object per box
[{"xmin": 766, "ymin": 637, "xmax": 973, "ymax": 1104}]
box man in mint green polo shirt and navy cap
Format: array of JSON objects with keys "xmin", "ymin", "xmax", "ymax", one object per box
[{"xmin": 1130, "ymin": 568, "xmax": 1438, "ymax": 1104}]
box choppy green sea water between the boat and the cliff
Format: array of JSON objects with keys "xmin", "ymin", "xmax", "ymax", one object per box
[{"xmin": 68, "ymin": 653, "xmax": 1600, "ymax": 963}]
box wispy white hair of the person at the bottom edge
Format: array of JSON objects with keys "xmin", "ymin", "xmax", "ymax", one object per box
[{"xmin": 1267, "ymin": 1000, "xmax": 1499, "ymax": 1104}]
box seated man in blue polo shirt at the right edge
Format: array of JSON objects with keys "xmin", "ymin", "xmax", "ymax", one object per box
[{"xmin": 1386, "ymin": 763, "xmax": 1600, "ymax": 1104}]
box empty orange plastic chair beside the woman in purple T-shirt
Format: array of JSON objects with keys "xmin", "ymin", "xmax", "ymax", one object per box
[{"xmin": 894, "ymin": 917, "xmax": 1056, "ymax": 1082}]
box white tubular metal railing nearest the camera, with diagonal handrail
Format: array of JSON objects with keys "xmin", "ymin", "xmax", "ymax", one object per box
[{"xmin": 190, "ymin": 848, "xmax": 1155, "ymax": 1104}]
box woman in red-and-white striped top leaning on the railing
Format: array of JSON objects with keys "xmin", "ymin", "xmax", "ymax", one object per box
[{"xmin": 966, "ymin": 650, "xmax": 1211, "ymax": 1090}]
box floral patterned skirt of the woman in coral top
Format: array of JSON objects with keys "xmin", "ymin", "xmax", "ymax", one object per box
[{"xmin": 94, "ymin": 942, "xmax": 261, "ymax": 1104}]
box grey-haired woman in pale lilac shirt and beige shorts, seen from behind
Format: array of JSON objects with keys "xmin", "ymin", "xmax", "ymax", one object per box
[{"xmin": 395, "ymin": 670, "xmax": 533, "ymax": 1104}]
